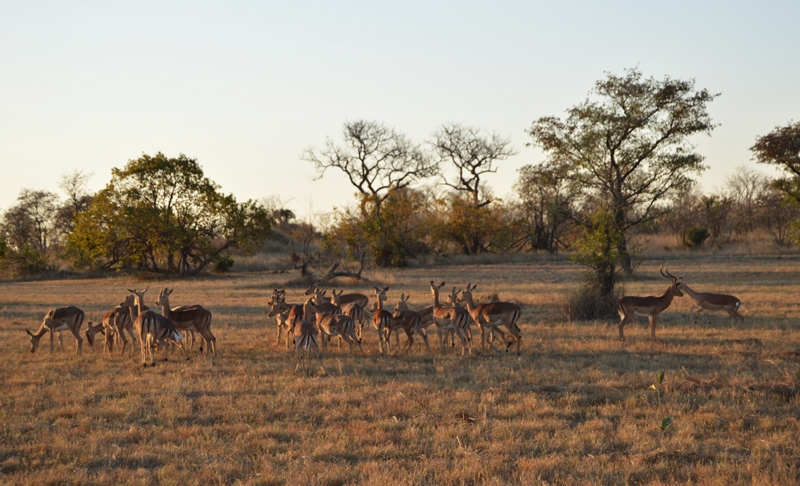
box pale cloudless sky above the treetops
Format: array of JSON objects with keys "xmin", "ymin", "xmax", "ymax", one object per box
[{"xmin": 0, "ymin": 0, "xmax": 800, "ymax": 216}]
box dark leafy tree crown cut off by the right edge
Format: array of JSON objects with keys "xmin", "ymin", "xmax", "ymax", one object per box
[{"xmin": 750, "ymin": 122, "xmax": 800, "ymax": 204}]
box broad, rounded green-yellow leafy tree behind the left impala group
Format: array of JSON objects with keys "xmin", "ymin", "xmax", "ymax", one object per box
[{"xmin": 68, "ymin": 152, "xmax": 272, "ymax": 274}]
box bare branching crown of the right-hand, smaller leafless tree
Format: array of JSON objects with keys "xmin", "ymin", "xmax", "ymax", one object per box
[{"xmin": 428, "ymin": 122, "xmax": 517, "ymax": 205}]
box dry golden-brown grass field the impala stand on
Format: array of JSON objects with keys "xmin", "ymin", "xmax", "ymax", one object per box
[{"xmin": 0, "ymin": 256, "xmax": 800, "ymax": 486}]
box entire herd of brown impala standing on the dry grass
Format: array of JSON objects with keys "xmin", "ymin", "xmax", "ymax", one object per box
[{"xmin": 20, "ymin": 266, "xmax": 744, "ymax": 373}]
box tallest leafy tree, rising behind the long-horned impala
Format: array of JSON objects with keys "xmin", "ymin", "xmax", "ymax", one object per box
[{"xmin": 528, "ymin": 69, "xmax": 716, "ymax": 308}]
